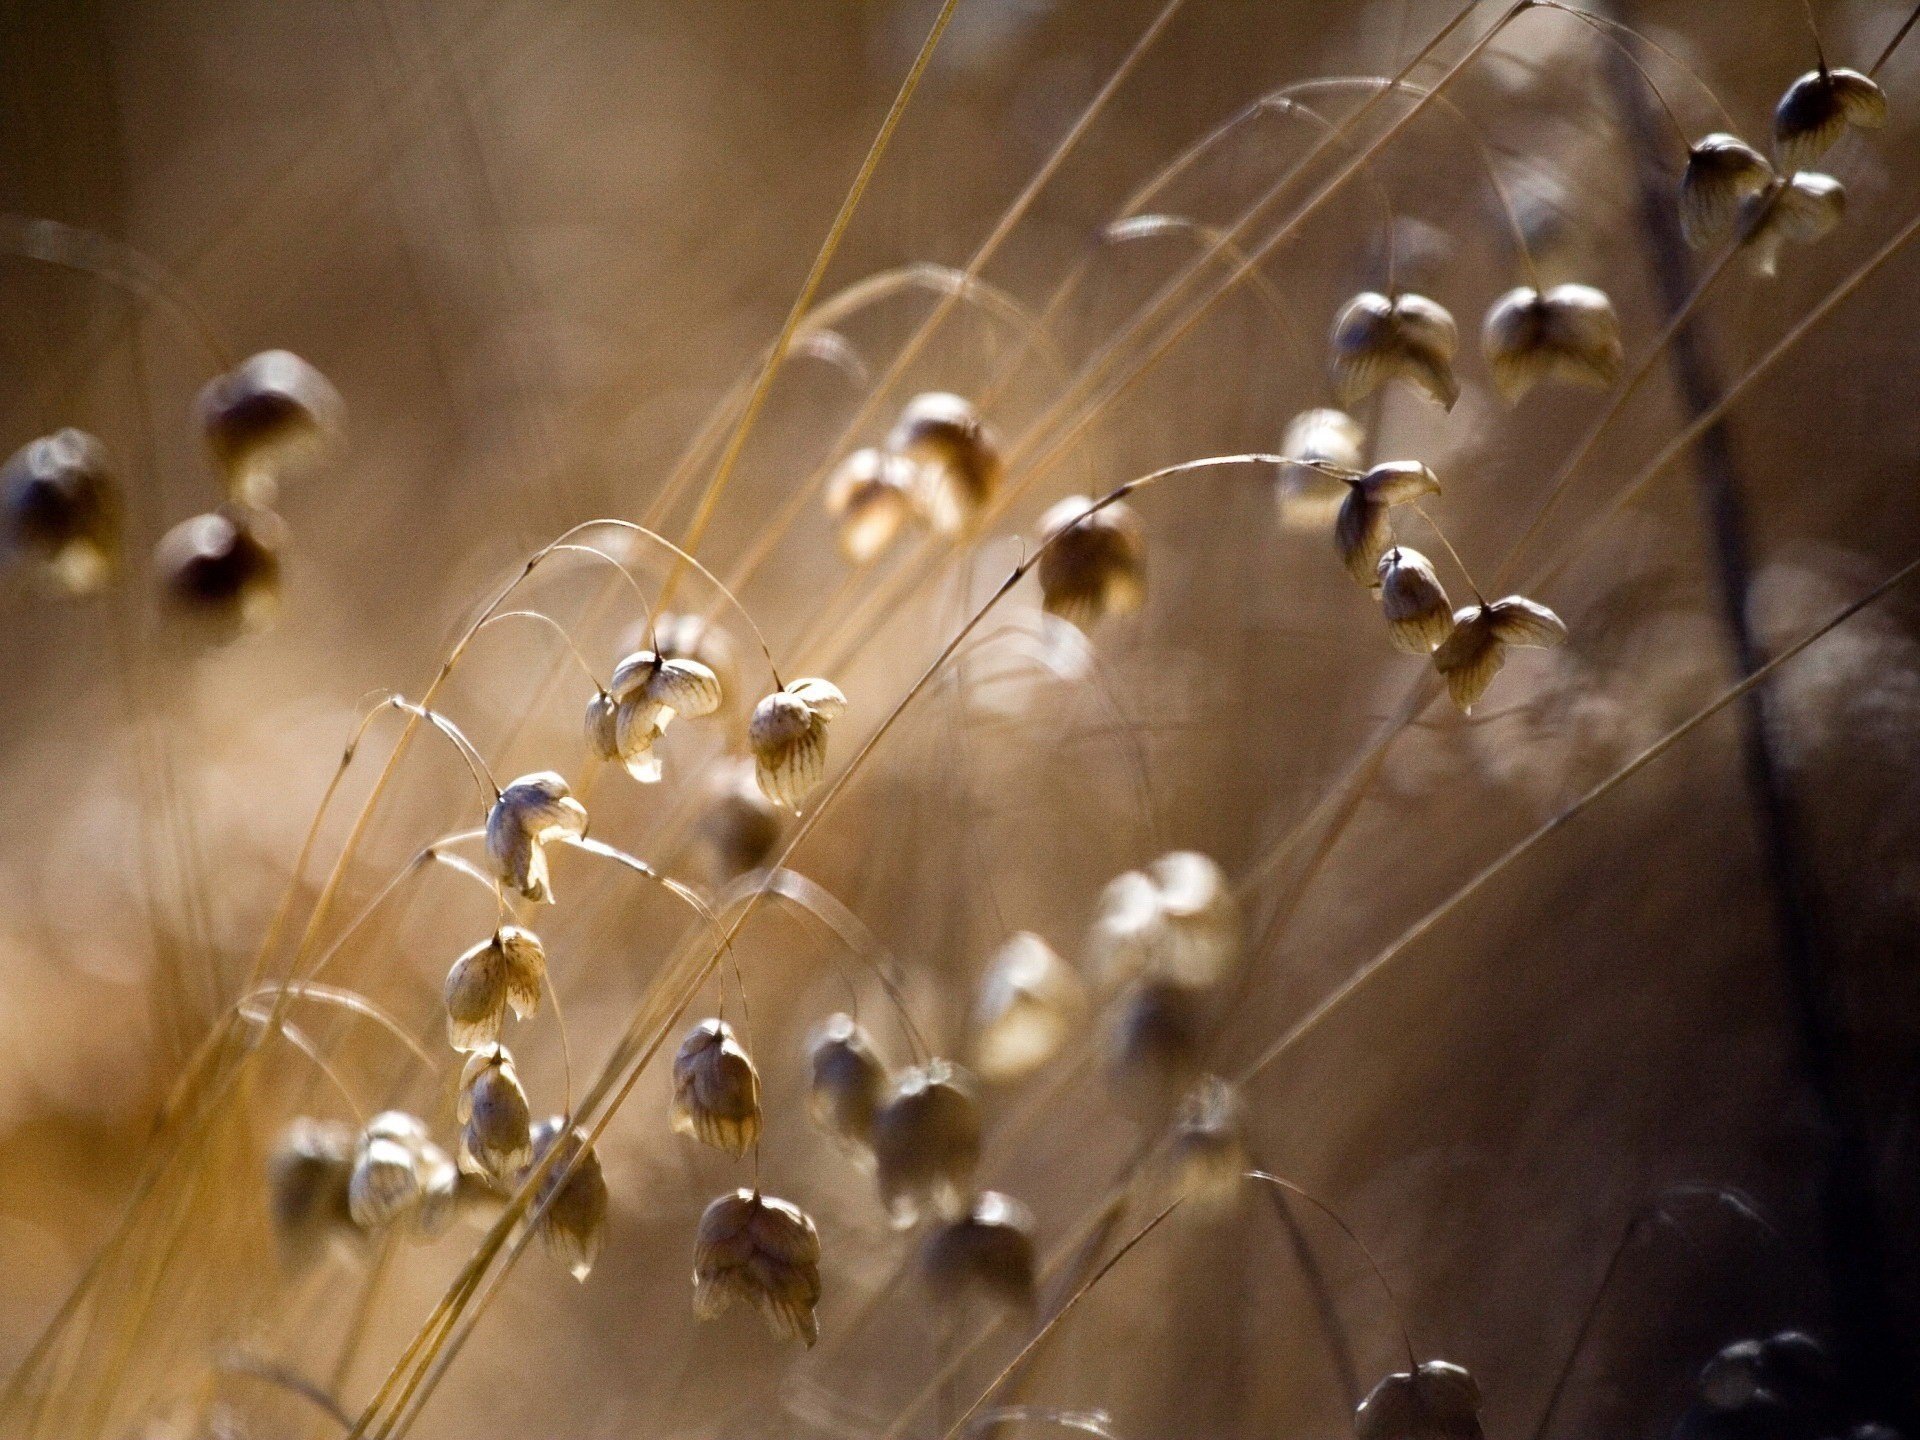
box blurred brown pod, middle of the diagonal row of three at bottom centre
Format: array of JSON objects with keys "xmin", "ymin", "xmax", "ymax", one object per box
[{"xmin": 872, "ymin": 1060, "xmax": 981, "ymax": 1229}]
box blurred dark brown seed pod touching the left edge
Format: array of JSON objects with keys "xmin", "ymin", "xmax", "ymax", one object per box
[{"xmin": 0, "ymin": 430, "xmax": 121, "ymax": 595}]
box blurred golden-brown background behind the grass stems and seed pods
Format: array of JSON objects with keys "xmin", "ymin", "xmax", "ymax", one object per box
[{"xmin": 0, "ymin": 0, "xmax": 1920, "ymax": 1440}]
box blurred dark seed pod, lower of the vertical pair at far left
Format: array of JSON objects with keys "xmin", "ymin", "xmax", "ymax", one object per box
[{"xmin": 154, "ymin": 505, "xmax": 286, "ymax": 643}]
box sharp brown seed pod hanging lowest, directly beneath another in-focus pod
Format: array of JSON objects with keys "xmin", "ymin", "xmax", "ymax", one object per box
[{"xmin": 693, "ymin": 1190, "xmax": 820, "ymax": 1346}]
